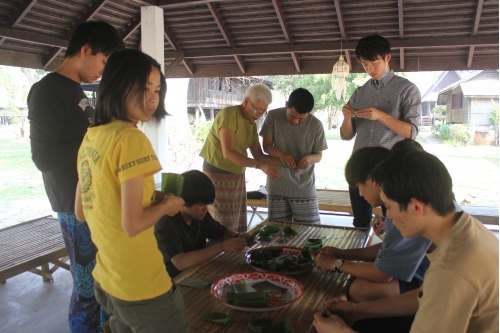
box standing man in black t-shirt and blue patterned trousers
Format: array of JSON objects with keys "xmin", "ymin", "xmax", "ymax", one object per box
[{"xmin": 28, "ymin": 21, "xmax": 125, "ymax": 332}]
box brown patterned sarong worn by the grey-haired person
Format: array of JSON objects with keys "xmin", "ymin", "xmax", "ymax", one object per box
[{"xmin": 203, "ymin": 171, "xmax": 247, "ymax": 232}]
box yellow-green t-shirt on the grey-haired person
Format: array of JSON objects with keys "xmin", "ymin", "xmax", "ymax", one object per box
[{"xmin": 200, "ymin": 106, "xmax": 258, "ymax": 174}]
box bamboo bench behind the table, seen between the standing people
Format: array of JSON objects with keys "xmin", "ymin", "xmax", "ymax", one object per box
[{"xmin": 247, "ymin": 189, "xmax": 382, "ymax": 225}]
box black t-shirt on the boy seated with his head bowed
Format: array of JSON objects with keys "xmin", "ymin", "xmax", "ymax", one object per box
[{"xmin": 155, "ymin": 213, "xmax": 227, "ymax": 278}]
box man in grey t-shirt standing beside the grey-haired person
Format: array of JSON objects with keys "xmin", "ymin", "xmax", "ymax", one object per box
[{"xmin": 260, "ymin": 88, "xmax": 328, "ymax": 223}]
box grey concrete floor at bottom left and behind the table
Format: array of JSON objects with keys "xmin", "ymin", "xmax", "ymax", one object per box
[{"xmin": 0, "ymin": 209, "xmax": 362, "ymax": 333}]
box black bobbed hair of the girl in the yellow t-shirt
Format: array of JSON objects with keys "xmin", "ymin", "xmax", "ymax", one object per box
[{"xmin": 94, "ymin": 49, "xmax": 168, "ymax": 126}]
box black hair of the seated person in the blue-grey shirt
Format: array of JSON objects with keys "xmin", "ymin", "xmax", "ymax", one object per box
[{"xmin": 344, "ymin": 147, "xmax": 391, "ymax": 188}]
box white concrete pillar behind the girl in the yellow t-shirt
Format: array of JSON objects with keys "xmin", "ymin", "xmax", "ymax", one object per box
[{"xmin": 141, "ymin": 6, "xmax": 167, "ymax": 185}]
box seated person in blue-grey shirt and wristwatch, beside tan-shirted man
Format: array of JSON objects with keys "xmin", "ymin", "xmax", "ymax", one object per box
[{"xmin": 315, "ymin": 147, "xmax": 430, "ymax": 303}]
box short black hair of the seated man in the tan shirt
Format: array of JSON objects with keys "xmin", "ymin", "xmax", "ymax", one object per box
[{"xmin": 372, "ymin": 151, "xmax": 455, "ymax": 216}]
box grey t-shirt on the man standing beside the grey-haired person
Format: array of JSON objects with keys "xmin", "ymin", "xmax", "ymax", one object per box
[{"xmin": 260, "ymin": 108, "xmax": 328, "ymax": 198}]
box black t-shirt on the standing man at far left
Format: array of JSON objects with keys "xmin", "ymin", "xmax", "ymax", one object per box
[{"xmin": 28, "ymin": 73, "xmax": 94, "ymax": 213}]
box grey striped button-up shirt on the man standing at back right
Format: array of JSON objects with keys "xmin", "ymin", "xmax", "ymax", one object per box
[{"xmin": 340, "ymin": 70, "xmax": 422, "ymax": 151}]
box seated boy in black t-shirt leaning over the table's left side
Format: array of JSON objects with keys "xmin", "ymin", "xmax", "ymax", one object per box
[{"xmin": 155, "ymin": 170, "xmax": 248, "ymax": 278}]
